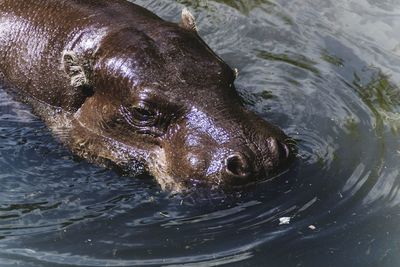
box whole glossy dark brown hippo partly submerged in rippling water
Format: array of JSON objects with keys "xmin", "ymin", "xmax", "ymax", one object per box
[{"xmin": 0, "ymin": 0, "xmax": 295, "ymax": 192}]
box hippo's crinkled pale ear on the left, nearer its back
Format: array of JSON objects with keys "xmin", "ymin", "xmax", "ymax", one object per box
[{"xmin": 61, "ymin": 50, "xmax": 89, "ymax": 88}]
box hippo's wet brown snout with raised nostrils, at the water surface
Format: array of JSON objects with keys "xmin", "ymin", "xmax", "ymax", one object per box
[{"xmin": 146, "ymin": 102, "xmax": 294, "ymax": 193}]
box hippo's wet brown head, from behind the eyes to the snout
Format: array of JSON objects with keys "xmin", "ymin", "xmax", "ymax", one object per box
[{"xmin": 64, "ymin": 8, "xmax": 295, "ymax": 191}]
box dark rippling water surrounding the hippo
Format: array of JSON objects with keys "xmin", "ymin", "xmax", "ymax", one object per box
[{"xmin": 0, "ymin": 0, "xmax": 400, "ymax": 267}]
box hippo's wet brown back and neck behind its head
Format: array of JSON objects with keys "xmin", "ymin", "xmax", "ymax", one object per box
[{"xmin": 0, "ymin": 0, "xmax": 165, "ymax": 110}]
